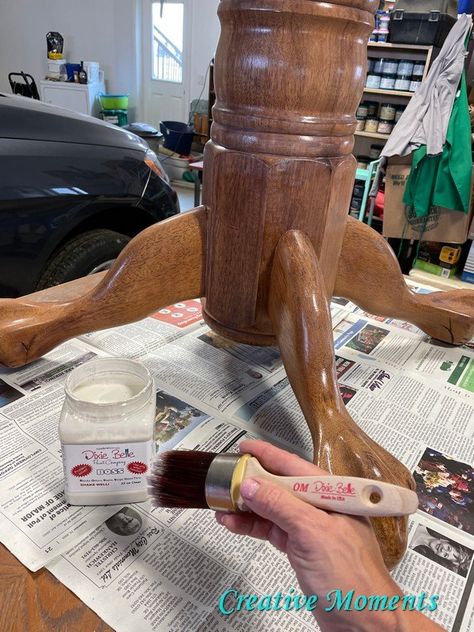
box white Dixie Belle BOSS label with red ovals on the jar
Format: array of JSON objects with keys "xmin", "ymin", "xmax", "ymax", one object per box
[{"xmin": 62, "ymin": 440, "xmax": 153, "ymax": 493}]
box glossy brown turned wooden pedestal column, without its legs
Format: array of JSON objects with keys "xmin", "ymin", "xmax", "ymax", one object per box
[{"xmin": 203, "ymin": 0, "xmax": 377, "ymax": 344}]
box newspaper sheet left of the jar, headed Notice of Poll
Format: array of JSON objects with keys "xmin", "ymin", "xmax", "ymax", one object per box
[{"xmin": 0, "ymin": 341, "xmax": 124, "ymax": 571}]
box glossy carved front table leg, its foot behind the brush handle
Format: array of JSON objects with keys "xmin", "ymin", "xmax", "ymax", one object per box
[{"xmin": 269, "ymin": 231, "xmax": 414, "ymax": 568}]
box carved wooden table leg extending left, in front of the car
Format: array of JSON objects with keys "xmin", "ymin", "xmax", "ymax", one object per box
[{"xmin": 0, "ymin": 207, "xmax": 207, "ymax": 367}]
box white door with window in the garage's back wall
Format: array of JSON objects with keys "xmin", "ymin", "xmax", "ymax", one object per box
[{"xmin": 142, "ymin": 0, "xmax": 192, "ymax": 127}]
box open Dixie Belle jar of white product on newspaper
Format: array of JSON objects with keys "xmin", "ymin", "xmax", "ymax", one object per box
[{"xmin": 59, "ymin": 358, "xmax": 156, "ymax": 505}]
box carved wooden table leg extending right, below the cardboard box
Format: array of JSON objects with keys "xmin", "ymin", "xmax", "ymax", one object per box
[{"xmin": 334, "ymin": 217, "xmax": 474, "ymax": 344}]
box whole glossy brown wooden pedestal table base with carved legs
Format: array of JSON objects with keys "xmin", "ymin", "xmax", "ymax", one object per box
[{"xmin": 0, "ymin": 0, "xmax": 474, "ymax": 567}]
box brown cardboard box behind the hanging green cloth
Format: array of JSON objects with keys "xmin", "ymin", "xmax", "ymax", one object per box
[{"xmin": 383, "ymin": 158, "xmax": 474, "ymax": 244}]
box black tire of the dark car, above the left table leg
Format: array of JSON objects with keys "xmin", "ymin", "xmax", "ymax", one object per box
[{"xmin": 36, "ymin": 229, "xmax": 130, "ymax": 290}]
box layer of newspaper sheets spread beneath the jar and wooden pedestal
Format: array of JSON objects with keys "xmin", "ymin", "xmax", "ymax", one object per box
[{"xmin": 0, "ymin": 288, "xmax": 474, "ymax": 632}]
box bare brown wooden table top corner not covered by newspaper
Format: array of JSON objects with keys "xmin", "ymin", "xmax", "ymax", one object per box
[{"xmin": 0, "ymin": 544, "xmax": 113, "ymax": 632}]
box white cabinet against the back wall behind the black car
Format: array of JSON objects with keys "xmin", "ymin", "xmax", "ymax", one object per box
[{"xmin": 40, "ymin": 79, "xmax": 105, "ymax": 116}]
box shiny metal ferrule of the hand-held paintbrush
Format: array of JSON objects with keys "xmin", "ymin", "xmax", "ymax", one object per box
[{"xmin": 205, "ymin": 454, "xmax": 249, "ymax": 511}]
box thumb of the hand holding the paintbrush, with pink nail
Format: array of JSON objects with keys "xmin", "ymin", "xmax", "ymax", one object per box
[{"xmin": 240, "ymin": 478, "xmax": 327, "ymax": 537}]
